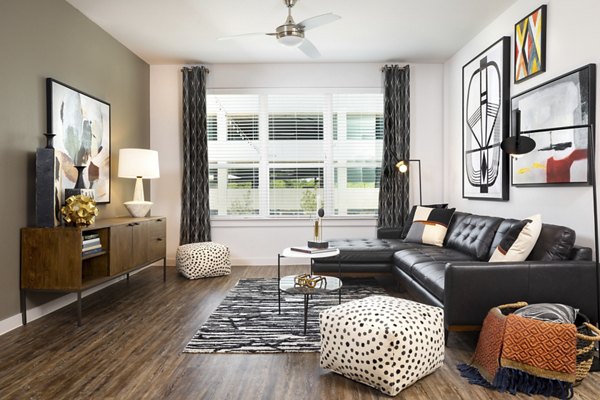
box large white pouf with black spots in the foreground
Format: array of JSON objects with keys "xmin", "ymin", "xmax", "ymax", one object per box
[{"xmin": 319, "ymin": 296, "xmax": 444, "ymax": 396}]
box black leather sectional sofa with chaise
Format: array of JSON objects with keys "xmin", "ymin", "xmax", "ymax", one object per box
[{"xmin": 313, "ymin": 212, "xmax": 598, "ymax": 331}]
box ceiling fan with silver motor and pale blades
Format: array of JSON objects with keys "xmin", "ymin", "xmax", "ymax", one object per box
[{"xmin": 219, "ymin": 0, "xmax": 341, "ymax": 58}]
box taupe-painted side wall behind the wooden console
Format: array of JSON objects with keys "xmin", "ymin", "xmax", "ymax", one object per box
[{"xmin": 0, "ymin": 0, "xmax": 150, "ymax": 322}]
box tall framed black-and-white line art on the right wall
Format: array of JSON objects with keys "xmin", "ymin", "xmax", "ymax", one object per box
[{"xmin": 462, "ymin": 36, "xmax": 510, "ymax": 200}]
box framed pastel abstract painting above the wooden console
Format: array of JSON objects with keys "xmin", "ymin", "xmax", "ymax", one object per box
[{"xmin": 46, "ymin": 78, "xmax": 110, "ymax": 204}]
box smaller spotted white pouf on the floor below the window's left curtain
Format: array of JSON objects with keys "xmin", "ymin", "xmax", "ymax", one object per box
[{"xmin": 175, "ymin": 242, "xmax": 231, "ymax": 279}]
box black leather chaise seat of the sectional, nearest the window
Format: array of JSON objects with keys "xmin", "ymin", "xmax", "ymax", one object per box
[{"xmin": 318, "ymin": 239, "xmax": 414, "ymax": 264}]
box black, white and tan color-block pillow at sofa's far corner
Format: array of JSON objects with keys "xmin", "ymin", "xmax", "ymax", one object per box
[{"xmin": 404, "ymin": 207, "xmax": 454, "ymax": 247}]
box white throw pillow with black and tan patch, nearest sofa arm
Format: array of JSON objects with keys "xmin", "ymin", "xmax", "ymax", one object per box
[{"xmin": 490, "ymin": 214, "xmax": 542, "ymax": 262}]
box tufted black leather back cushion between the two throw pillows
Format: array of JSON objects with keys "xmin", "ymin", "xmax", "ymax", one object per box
[{"xmin": 446, "ymin": 214, "xmax": 502, "ymax": 261}]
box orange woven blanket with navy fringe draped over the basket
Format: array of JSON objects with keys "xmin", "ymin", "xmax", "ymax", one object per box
[{"xmin": 458, "ymin": 308, "xmax": 577, "ymax": 399}]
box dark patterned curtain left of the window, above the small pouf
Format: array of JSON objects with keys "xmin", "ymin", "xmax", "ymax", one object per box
[{"xmin": 179, "ymin": 67, "xmax": 210, "ymax": 244}]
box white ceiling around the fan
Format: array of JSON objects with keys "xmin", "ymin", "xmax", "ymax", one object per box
[{"xmin": 67, "ymin": 0, "xmax": 517, "ymax": 64}]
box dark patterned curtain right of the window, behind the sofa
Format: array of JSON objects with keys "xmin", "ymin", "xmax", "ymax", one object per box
[{"xmin": 377, "ymin": 65, "xmax": 410, "ymax": 228}]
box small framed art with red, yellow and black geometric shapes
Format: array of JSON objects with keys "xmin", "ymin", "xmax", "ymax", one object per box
[{"xmin": 514, "ymin": 5, "xmax": 547, "ymax": 83}]
